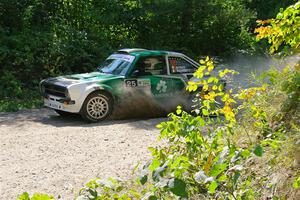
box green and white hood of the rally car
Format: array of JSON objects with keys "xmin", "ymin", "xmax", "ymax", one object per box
[{"xmin": 45, "ymin": 72, "xmax": 120, "ymax": 87}]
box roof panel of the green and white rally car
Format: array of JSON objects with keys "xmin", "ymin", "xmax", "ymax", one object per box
[{"xmin": 117, "ymin": 48, "xmax": 184, "ymax": 56}]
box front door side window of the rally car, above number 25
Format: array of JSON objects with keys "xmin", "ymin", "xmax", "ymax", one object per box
[{"xmin": 137, "ymin": 56, "xmax": 167, "ymax": 75}]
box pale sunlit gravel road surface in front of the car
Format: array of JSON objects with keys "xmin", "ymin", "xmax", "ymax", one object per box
[{"xmin": 0, "ymin": 109, "xmax": 164, "ymax": 200}]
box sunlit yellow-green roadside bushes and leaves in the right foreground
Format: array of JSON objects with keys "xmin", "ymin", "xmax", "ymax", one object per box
[{"xmin": 19, "ymin": 2, "xmax": 300, "ymax": 200}]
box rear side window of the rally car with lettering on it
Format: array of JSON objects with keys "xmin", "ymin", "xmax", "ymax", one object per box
[{"xmin": 168, "ymin": 57, "xmax": 197, "ymax": 74}]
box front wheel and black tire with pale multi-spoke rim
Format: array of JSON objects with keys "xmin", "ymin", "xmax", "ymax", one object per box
[{"xmin": 80, "ymin": 92, "xmax": 113, "ymax": 122}]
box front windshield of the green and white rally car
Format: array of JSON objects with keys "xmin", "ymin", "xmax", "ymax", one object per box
[{"xmin": 98, "ymin": 55, "xmax": 134, "ymax": 76}]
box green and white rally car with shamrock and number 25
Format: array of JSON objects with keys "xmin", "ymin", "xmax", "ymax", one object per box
[{"xmin": 40, "ymin": 49, "xmax": 223, "ymax": 122}]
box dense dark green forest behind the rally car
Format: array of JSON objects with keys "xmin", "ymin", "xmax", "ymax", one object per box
[{"xmin": 0, "ymin": 0, "xmax": 296, "ymax": 111}]
